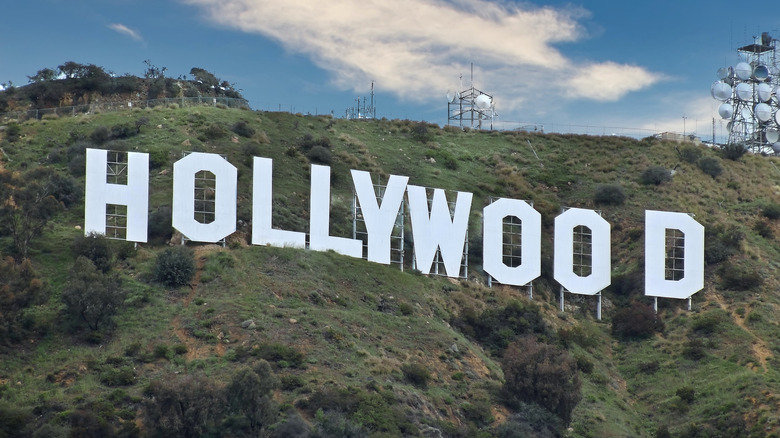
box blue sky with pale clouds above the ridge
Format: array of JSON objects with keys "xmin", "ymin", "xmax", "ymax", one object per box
[{"xmin": 0, "ymin": 0, "xmax": 780, "ymax": 141}]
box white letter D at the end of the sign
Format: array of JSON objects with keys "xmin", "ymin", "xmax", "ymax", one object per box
[{"xmin": 645, "ymin": 210, "xmax": 704, "ymax": 299}]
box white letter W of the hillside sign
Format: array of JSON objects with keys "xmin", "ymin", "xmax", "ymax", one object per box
[{"xmin": 406, "ymin": 186, "xmax": 473, "ymax": 278}]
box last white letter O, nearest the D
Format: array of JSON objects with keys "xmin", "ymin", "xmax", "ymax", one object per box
[{"xmin": 553, "ymin": 208, "xmax": 611, "ymax": 295}]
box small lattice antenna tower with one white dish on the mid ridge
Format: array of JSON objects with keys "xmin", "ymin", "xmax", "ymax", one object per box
[{"xmin": 447, "ymin": 64, "xmax": 498, "ymax": 130}]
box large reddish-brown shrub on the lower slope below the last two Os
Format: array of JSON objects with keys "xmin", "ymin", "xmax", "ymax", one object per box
[{"xmin": 501, "ymin": 337, "xmax": 582, "ymax": 424}]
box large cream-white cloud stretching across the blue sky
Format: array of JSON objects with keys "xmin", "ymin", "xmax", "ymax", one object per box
[{"xmin": 180, "ymin": 0, "xmax": 663, "ymax": 111}]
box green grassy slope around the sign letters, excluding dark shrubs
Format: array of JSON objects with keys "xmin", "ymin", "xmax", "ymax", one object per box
[{"xmin": 0, "ymin": 107, "xmax": 780, "ymax": 437}]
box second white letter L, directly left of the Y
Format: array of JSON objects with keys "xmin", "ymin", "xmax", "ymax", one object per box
[{"xmin": 309, "ymin": 164, "xmax": 363, "ymax": 258}]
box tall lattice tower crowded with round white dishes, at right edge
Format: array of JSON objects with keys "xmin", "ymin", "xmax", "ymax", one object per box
[{"xmin": 710, "ymin": 32, "xmax": 780, "ymax": 153}]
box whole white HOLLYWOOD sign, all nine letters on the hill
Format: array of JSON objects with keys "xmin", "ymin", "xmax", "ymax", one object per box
[{"xmin": 84, "ymin": 149, "xmax": 704, "ymax": 299}]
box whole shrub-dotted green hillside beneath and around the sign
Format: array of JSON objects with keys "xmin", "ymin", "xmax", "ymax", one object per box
[{"xmin": 0, "ymin": 105, "xmax": 780, "ymax": 437}]
